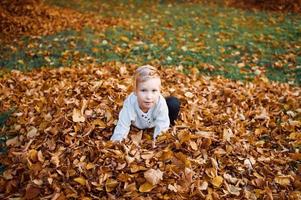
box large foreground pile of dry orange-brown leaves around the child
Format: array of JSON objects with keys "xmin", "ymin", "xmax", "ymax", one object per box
[{"xmin": 0, "ymin": 63, "xmax": 301, "ymax": 199}]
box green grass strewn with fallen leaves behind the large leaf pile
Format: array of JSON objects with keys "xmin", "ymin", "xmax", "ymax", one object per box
[{"xmin": 0, "ymin": 0, "xmax": 301, "ymax": 85}]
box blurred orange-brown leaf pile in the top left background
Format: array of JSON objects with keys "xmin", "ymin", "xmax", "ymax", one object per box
[{"xmin": 0, "ymin": 0, "xmax": 124, "ymax": 40}]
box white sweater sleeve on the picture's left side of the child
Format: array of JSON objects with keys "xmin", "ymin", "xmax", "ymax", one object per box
[{"xmin": 111, "ymin": 104, "xmax": 132, "ymax": 141}]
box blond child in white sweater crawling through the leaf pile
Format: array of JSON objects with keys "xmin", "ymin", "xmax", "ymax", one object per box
[{"xmin": 111, "ymin": 65, "xmax": 180, "ymax": 141}]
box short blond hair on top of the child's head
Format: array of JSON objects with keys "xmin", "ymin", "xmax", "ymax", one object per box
[{"xmin": 134, "ymin": 65, "xmax": 160, "ymax": 90}]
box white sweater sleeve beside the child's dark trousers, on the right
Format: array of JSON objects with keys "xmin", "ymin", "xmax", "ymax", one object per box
[{"xmin": 153, "ymin": 99, "xmax": 170, "ymax": 140}]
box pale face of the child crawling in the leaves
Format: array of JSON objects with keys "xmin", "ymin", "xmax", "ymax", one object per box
[{"xmin": 135, "ymin": 78, "xmax": 161, "ymax": 112}]
